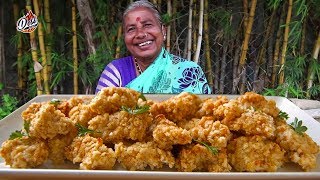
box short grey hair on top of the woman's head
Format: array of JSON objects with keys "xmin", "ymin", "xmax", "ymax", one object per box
[{"xmin": 122, "ymin": 0, "xmax": 162, "ymax": 24}]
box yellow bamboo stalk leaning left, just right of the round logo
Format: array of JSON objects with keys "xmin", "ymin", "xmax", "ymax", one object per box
[{"xmin": 33, "ymin": 0, "xmax": 50, "ymax": 94}]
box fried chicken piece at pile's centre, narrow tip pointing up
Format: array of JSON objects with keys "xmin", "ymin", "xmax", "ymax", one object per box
[{"xmin": 152, "ymin": 114, "xmax": 192, "ymax": 150}]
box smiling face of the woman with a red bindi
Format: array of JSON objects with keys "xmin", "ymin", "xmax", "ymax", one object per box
[{"xmin": 123, "ymin": 7, "xmax": 164, "ymax": 61}]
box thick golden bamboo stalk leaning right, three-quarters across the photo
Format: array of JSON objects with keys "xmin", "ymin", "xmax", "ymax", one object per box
[{"xmin": 238, "ymin": 0, "xmax": 257, "ymax": 94}]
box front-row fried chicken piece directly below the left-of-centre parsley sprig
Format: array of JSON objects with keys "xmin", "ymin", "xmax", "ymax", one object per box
[{"xmin": 65, "ymin": 134, "xmax": 116, "ymax": 170}]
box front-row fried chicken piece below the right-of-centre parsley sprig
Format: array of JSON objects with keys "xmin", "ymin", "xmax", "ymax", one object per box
[{"xmin": 175, "ymin": 144, "xmax": 231, "ymax": 172}]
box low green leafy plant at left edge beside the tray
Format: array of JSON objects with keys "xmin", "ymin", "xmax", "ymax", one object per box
[{"xmin": 0, "ymin": 83, "xmax": 19, "ymax": 120}]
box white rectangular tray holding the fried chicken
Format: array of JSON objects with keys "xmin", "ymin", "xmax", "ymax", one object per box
[{"xmin": 0, "ymin": 94, "xmax": 320, "ymax": 179}]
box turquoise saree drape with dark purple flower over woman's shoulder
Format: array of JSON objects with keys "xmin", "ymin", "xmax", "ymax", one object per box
[{"xmin": 126, "ymin": 48, "xmax": 211, "ymax": 94}]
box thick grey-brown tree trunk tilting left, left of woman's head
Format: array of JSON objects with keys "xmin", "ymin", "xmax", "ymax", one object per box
[{"xmin": 77, "ymin": 0, "xmax": 96, "ymax": 54}]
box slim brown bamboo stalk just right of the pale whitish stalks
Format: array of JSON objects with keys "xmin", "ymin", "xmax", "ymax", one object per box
[{"xmin": 203, "ymin": 0, "xmax": 213, "ymax": 89}]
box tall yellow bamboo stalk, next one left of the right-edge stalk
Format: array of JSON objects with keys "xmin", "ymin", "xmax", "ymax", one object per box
[{"xmin": 279, "ymin": 0, "xmax": 292, "ymax": 84}]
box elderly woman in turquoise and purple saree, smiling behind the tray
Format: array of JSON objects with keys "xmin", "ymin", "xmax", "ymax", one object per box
[{"xmin": 96, "ymin": 1, "xmax": 211, "ymax": 94}]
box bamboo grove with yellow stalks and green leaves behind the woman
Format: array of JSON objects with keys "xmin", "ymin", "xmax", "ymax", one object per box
[{"xmin": 0, "ymin": 0, "xmax": 320, "ymax": 102}]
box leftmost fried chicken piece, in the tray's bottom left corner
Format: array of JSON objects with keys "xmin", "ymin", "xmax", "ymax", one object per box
[{"xmin": 0, "ymin": 136, "xmax": 49, "ymax": 168}]
